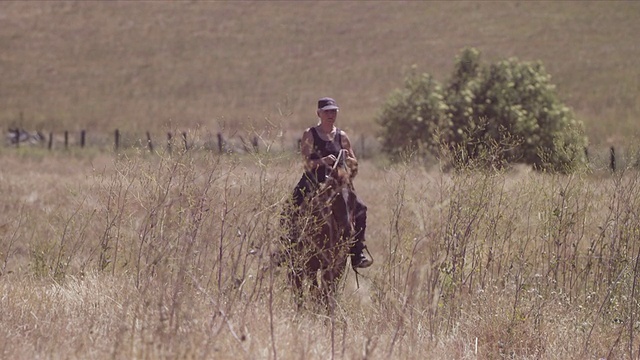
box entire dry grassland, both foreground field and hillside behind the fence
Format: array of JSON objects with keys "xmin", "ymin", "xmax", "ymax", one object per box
[{"xmin": 0, "ymin": 1, "xmax": 640, "ymax": 359}]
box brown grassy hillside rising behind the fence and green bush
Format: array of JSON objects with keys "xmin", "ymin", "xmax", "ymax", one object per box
[{"xmin": 0, "ymin": 1, "xmax": 640, "ymax": 144}]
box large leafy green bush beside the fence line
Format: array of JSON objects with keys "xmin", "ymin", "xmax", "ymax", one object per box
[{"xmin": 378, "ymin": 49, "xmax": 587, "ymax": 172}]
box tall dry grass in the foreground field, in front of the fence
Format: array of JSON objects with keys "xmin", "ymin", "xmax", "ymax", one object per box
[{"xmin": 0, "ymin": 142, "xmax": 640, "ymax": 359}]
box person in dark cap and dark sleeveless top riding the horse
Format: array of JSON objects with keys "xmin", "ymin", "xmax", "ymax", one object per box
[{"xmin": 285, "ymin": 97, "xmax": 373, "ymax": 268}]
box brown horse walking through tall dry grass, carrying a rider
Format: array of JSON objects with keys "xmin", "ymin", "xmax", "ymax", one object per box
[{"xmin": 289, "ymin": 167, "xmax": 356, "ymax": 310}]
